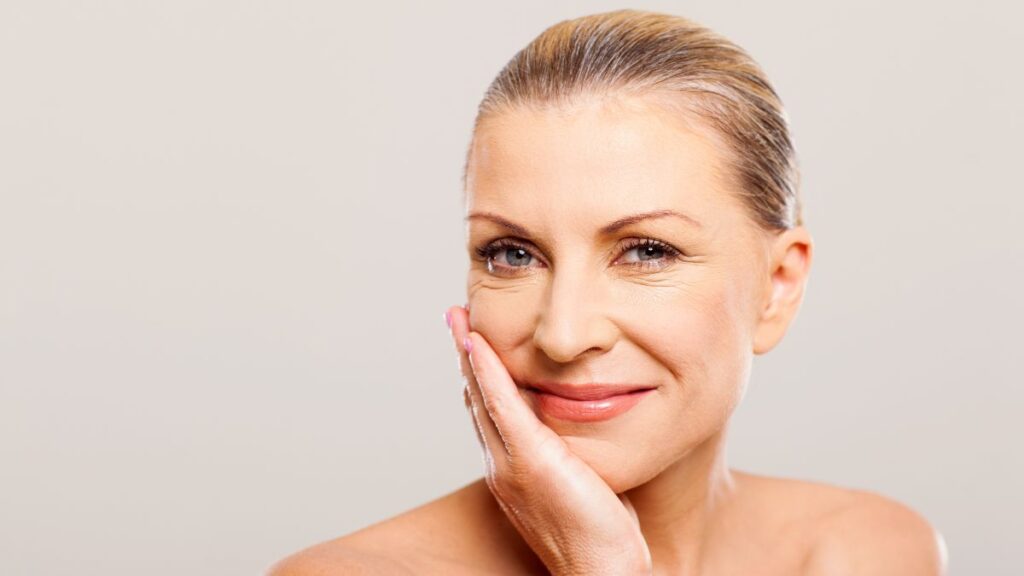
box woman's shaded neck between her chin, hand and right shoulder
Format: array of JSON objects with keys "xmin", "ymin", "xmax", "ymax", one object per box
[{"xmin": 625, "ymin": 428, "xmax": 736, "ymax": 574}]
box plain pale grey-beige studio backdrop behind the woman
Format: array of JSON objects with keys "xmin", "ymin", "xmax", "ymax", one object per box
[{"xmin": 0, "ymin": 0, "xmax": 1024, "ymax": 576}]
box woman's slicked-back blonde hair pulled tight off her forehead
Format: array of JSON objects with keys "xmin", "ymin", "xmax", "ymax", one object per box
[{"xmin": 463, "ymin": 9, "xmax": 803, "ymax": 231}]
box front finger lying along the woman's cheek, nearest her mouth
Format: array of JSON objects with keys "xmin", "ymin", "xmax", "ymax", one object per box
[{"xmin": 467, "ymin": 332, "xmax": 554, "ymax": 454}]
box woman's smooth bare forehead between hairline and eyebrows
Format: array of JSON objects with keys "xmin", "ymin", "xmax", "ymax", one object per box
[{"xmin": 466, "ymin": 96, "xmax": 738, "ymax": 225}]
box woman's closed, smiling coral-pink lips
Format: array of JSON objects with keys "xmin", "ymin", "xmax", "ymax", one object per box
[{"xmin": 526, "ymin": 382, "xmax": 654, "ymax": 422}]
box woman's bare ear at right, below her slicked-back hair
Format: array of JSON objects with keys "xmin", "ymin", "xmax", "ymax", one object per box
[{"xmin": 754, "ymin": 225, "xmax": 814, "ymax": 355}]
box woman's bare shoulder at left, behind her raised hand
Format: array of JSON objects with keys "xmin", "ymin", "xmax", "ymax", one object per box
[{"xmin": 266, "ymin": 480, "xmax": 544, "ymax": 576}]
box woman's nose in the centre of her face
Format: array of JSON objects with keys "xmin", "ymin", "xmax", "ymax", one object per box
[{"xmin": 534, "ymin": 262, "xmax": 617, "ymax": 363}]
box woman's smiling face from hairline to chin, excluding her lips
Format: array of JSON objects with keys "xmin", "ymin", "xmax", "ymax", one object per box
[{"xmin": 466, "ymin": 93, "xmax": 771, "ymax": 492}]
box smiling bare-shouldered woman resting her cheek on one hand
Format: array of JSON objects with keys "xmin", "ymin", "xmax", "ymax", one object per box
[{"xmin": 271, "ymin": 10, "xmax": 945, "ymax": 576}]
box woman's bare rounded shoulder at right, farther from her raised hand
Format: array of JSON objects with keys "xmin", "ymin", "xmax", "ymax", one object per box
[{"xmin": 803, "ymin": 487, "xmax": 947, "ymax": 576}]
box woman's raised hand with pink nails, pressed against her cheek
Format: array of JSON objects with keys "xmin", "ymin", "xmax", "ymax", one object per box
[{"xmin": 447, "ymin": 306, "xmax": 652, "ymax": 576}]
